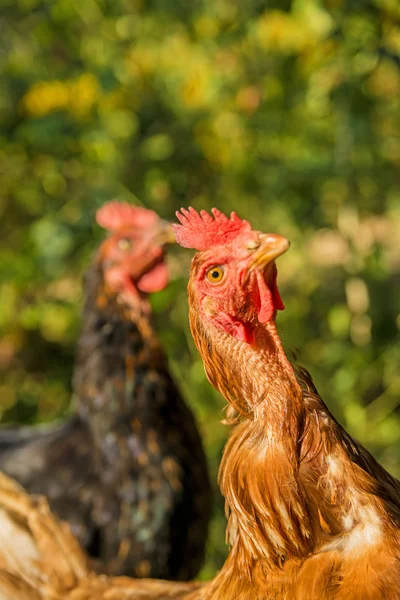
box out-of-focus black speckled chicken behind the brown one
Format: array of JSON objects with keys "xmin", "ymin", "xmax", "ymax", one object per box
[{"xmin": 0, "ymin": 202, "xmax": 211, "ymax": 580}]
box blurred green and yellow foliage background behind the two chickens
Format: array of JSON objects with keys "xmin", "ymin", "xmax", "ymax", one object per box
[{"xmin": 0, "ymin": 0, "xmax": 400, "ymax": 577}]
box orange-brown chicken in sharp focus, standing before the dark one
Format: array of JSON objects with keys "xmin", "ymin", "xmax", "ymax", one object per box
[{"xmin": 174, "ymin": 209, "xmax": 400, "ymax": 600}]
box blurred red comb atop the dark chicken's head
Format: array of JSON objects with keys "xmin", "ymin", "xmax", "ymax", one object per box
[{"xmin": 96, "ymin": 200, "xmax": 158, "ymax": 231}]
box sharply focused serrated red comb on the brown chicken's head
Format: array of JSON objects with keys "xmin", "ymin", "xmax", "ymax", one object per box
[{"xmin": 172, "ymin": 206, "xmax": 251, "ymax": 250}]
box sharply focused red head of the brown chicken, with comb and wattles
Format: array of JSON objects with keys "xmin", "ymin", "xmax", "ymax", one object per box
[{"xmin": 172, "ymin": 208, "xmax": 289, "ymax": 344}]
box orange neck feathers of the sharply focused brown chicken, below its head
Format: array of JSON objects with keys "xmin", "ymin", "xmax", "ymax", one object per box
[{"xmin": 190, "ymin": 300, "xmax": 313, "ymax": 578}]
